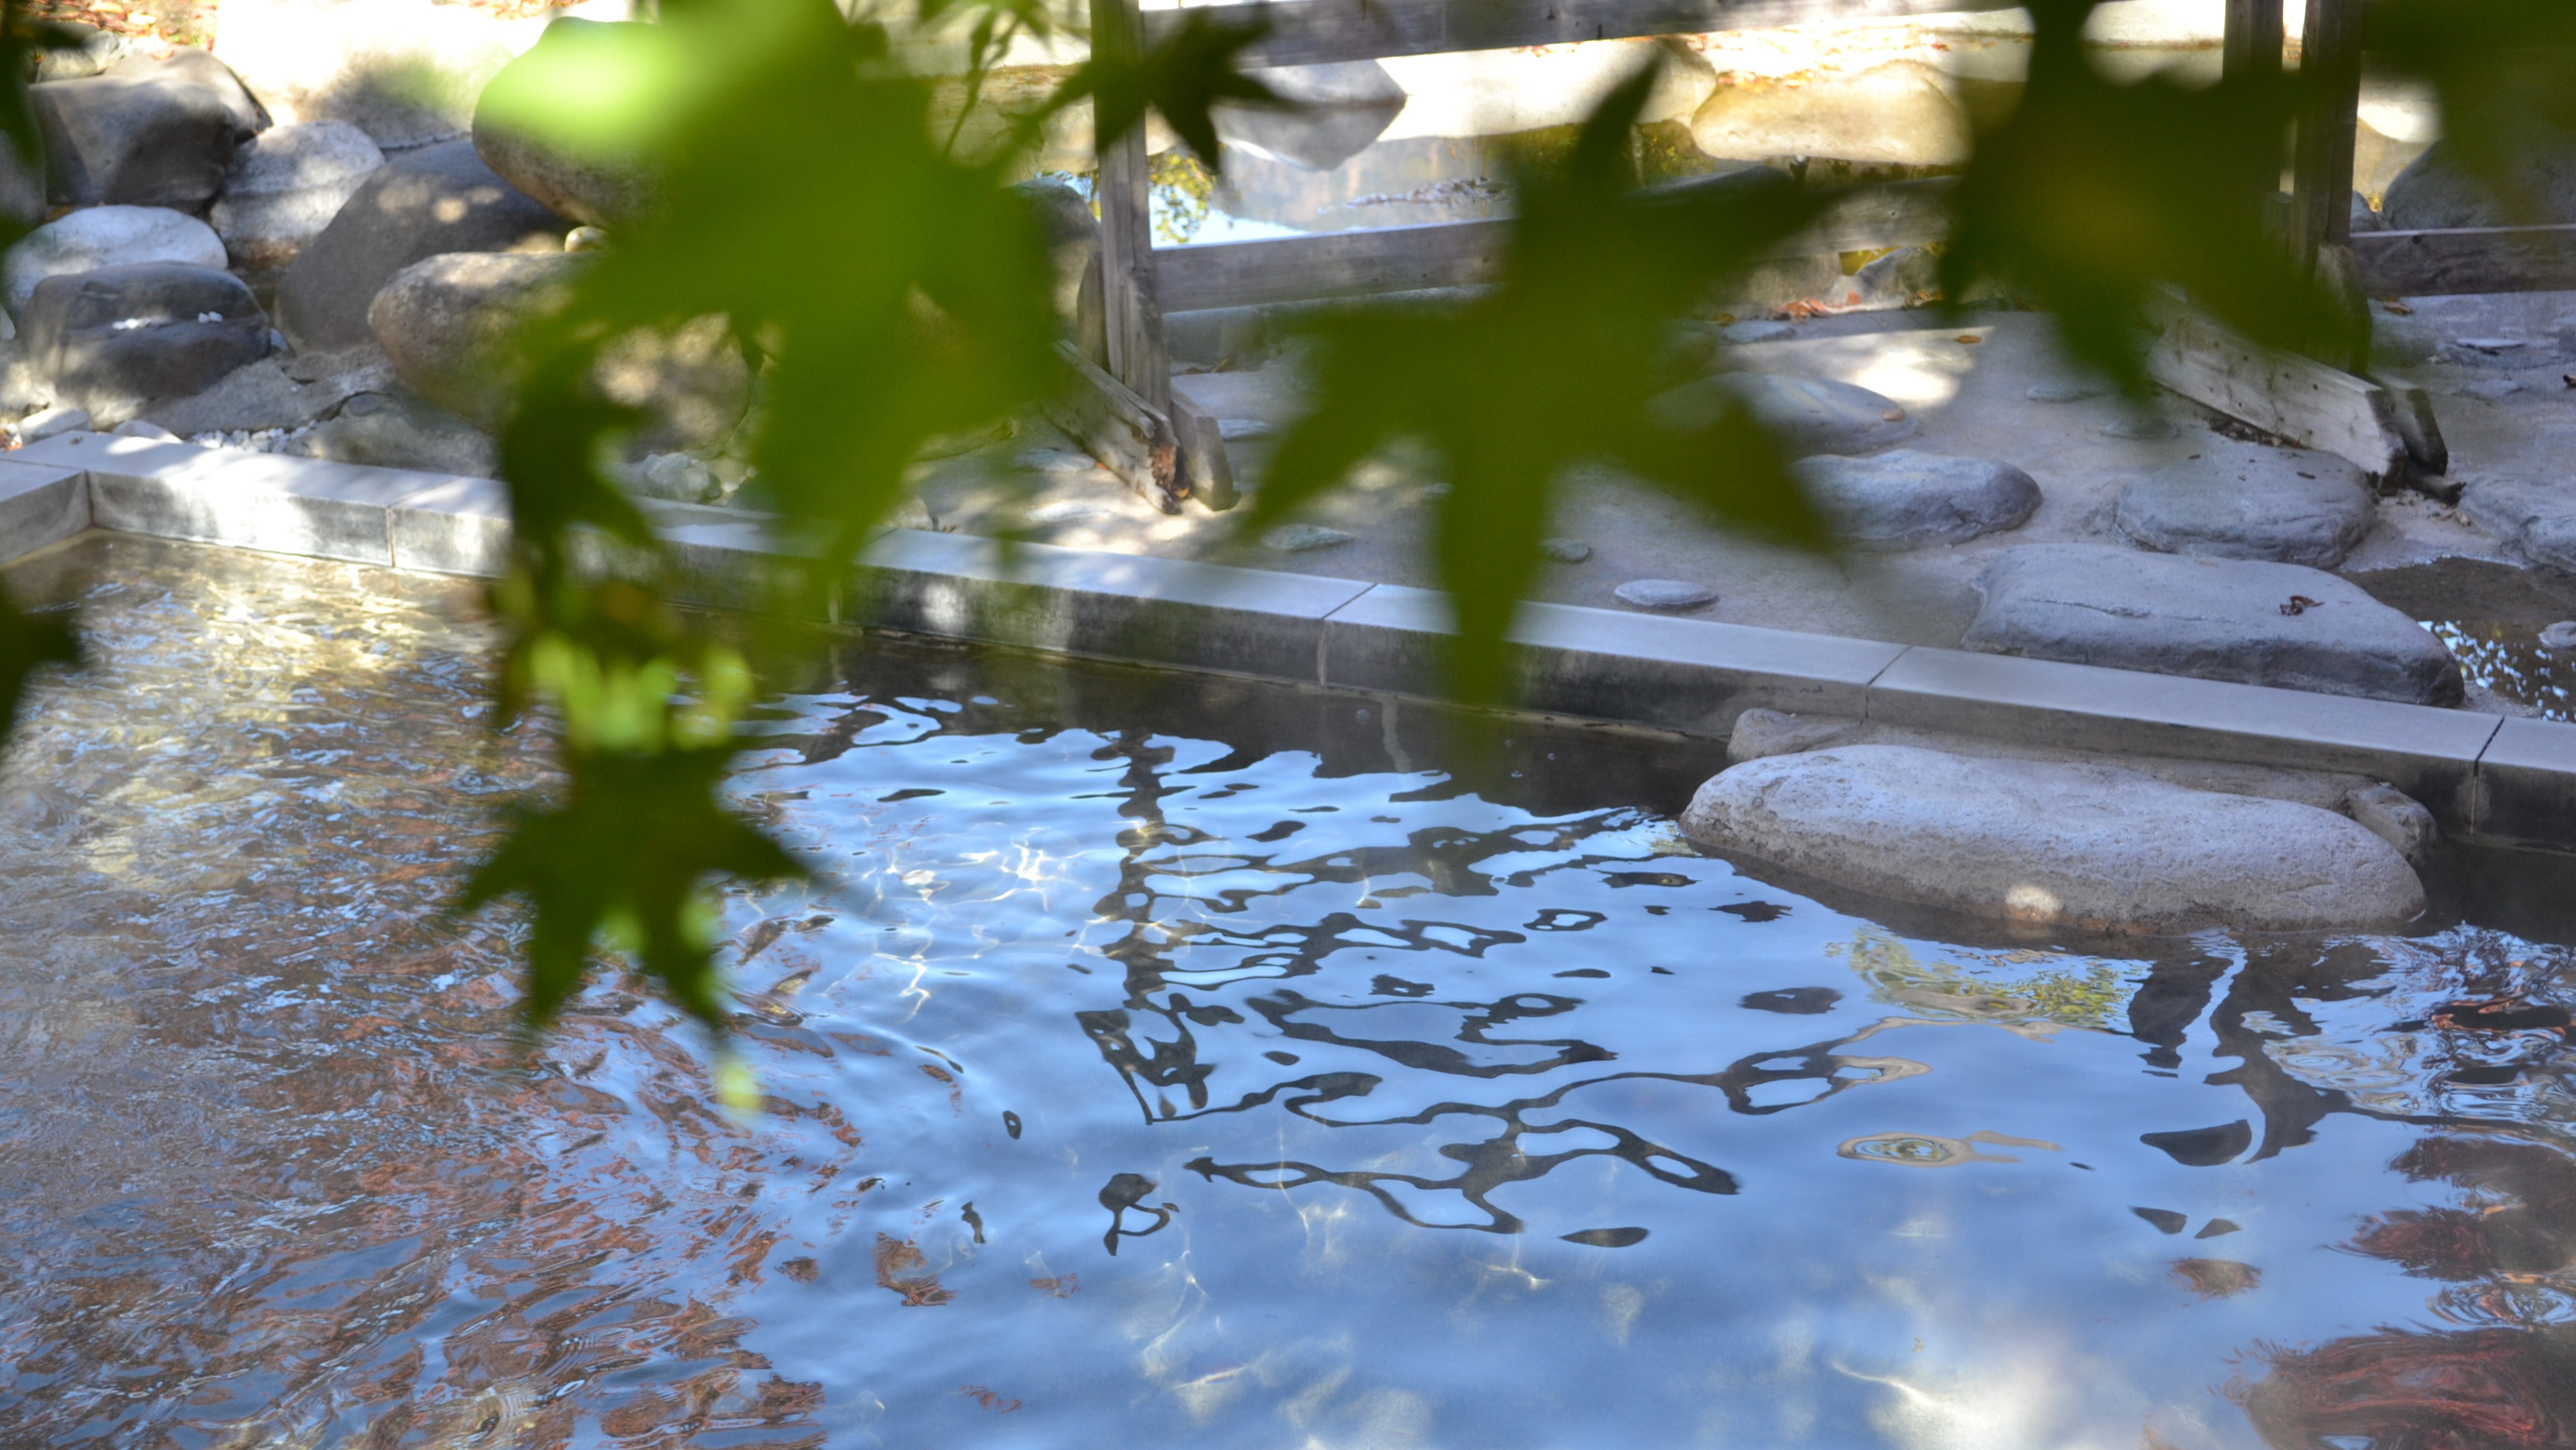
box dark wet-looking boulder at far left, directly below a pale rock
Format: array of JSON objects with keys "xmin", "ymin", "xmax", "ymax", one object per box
[{"xmin": 26, "ymin": 263, "xmax": 268, "ymax": 425}]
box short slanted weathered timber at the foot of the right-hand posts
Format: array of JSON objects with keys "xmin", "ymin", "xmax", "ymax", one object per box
[{"xmin": 2146, "ymin": 299, "xmax": 2447, "ymax": 484}]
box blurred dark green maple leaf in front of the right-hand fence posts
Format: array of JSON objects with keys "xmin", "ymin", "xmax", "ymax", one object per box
[{"xmin": 1942, "ymin": 0, "xmax": 2352, "ymax": 391}]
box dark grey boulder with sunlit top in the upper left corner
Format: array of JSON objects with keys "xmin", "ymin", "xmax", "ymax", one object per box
[{"xmin": 29, "ymin": 49, "xmax": 268, "ymax": 211}]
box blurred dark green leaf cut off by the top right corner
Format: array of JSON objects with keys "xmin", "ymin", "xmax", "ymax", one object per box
[{"xmin": 2362, "ymin": 0, "xmax": 2576, "ymax": 221}]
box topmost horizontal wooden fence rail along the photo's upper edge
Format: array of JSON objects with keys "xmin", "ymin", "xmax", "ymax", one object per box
[{"xmin": 1144, "ymin": 0, "xmax": 2020, "ymax": 67}]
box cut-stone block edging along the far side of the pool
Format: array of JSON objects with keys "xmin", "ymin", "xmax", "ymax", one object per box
[{"xmin": 0, "ymin": 433, "xmax": 2576, "ymax": 850}]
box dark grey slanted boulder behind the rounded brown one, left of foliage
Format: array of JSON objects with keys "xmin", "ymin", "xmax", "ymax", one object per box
[{"xmin": 278, "ymin": 141, "xmax": 572, "ymax": 350}]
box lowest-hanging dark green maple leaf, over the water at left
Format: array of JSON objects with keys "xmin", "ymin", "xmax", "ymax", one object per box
[{"xmin": 456, "ymin": 747, "xmax": 804, "ymax": 1033}]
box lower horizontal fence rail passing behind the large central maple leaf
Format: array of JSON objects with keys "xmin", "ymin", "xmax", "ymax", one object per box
[{"xmin": 1154, "ymin": 178, "xmax": 1953, "ymax": 311}]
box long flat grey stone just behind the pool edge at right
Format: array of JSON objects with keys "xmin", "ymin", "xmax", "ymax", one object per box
[{"xmin": 1961, "ymin": 544, "xmax": 2463, "ymax": 706}]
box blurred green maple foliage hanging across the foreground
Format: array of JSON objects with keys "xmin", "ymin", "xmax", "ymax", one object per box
[{"xmin": 0, "ymin": 0, "xmax": 2576, "ymax": 1030}]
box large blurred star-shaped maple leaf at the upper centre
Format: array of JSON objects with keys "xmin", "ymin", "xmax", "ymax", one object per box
[{"xmin": 1244, "ymin": 72, "xmax": 1824, "ymax": 701}]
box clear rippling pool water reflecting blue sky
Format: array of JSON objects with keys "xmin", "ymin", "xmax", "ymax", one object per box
[{"xmin": 0, "ymin": 539, "xmax": 2576, "ymax": 1450}]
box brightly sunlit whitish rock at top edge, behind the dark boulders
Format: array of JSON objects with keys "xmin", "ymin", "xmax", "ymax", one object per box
[{"xmin": 214, "ymin": 0, "xmax": 546, "ymax": 147}]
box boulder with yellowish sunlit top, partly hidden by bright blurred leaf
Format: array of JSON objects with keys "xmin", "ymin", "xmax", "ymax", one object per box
[{"xmin": 474, "ymin": 21, "xmax": 662, "ymax": 232}]
